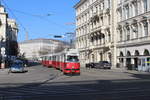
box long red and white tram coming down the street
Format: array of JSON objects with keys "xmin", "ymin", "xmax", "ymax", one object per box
[{"xmin": 41, "ymin": 49, "xmax": 80, "ymax": 74}]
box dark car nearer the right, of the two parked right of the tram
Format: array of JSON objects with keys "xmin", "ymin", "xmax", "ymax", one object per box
[{"xmin": 95, "ymin": 61, "xmax": 111, "ymax": 69}]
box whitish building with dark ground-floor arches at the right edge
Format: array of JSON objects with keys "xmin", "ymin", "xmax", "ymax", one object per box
[{"xmin": 117, "ymin": 0, "xmax": 150, "ymax": 71}]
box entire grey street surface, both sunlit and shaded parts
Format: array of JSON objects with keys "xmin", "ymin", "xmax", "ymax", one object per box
[{"xmin": 0, "ymin": 65, "xmax": 150, "ymax": 100}]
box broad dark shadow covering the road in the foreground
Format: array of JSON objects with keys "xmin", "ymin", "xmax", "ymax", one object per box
[{"xmin": 0, "ymin": 73, "xmax": 150, "ymax": 100}]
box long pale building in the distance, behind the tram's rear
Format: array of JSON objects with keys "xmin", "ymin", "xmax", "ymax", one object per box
[{"xmin": 19, "ymin": 39, "xmax": 68, "ymax": 59}]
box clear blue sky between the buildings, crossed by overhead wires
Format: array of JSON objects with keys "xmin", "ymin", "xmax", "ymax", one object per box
[{"xmin": 2, "ymin": 0, "xmax": 79, "ymax": 41}]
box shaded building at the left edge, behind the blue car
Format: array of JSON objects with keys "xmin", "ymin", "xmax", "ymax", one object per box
[{"xmin": 0, "ymin": 5, "xmax": 18, "ymax": 67}]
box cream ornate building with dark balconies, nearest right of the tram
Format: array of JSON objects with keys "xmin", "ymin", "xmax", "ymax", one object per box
[{"xmin": 75, "ymin": 0, "xmax": 116, "ymax": 65}]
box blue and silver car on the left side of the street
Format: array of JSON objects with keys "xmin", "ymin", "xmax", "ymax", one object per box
[{"xmin": 10, "ymin": 60, "xmax": 25, "ymax": 72}]
